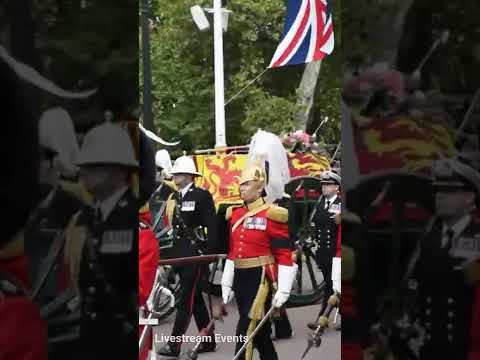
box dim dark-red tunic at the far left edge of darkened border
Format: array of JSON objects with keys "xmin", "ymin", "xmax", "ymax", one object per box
[{"xmin": 0, "ymin": 245, "xmax": 47, "ymax": 360}]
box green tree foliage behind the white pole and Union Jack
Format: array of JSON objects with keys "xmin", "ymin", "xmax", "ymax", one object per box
[{"xmin": 144, "ymin": 0, "xmax": 341, "ymax": 151}]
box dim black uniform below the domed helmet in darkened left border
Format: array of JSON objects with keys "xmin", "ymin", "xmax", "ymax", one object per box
[{"xmin": 77, "ymin": 189, "xmax": 138, "ymax": 360}]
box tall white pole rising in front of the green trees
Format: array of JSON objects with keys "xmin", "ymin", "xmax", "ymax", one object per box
[{"xmin": 213, "ymin": 0, "xmax": 227, "ymax": 148}]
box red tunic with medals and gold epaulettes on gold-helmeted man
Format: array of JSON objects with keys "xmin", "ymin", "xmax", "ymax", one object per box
[{"xmin": 228, "ymin": 199, "xmax": 293, "ymax": 266}]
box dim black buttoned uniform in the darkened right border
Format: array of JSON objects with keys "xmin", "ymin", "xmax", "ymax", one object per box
[{"xmin": 413, "ymin": 220, "xmax": 480, "ymax": 360}]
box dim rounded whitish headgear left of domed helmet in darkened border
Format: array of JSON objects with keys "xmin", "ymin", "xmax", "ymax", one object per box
[{"xmin": 38, "ymin": 107, "xmax": 80, "ymax": 170}]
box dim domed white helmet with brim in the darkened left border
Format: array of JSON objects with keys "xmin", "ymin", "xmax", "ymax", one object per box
[{"xmin": 76, "ymin": 122, "xmax": 138, "ymax": 167}]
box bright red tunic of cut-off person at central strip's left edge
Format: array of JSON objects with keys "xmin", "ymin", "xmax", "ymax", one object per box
[{"xmin": 138, "ymin": 209, "xmax": 159, "ymax": 360}]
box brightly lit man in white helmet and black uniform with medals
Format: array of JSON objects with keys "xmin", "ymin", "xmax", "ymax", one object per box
[{"xmin": 157, "ymin": 155, "xmax": 218, "ymax": 357}]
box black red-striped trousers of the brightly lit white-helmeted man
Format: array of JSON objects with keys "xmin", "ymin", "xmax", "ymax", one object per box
[{"xmin": 170, "ymin": 265, "xmax": 210, "ymax": 347}]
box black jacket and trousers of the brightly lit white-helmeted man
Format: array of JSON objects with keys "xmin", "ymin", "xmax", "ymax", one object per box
[{"xmin": 163, "ymin": 184, "xmax": 218, "ymax": 353}]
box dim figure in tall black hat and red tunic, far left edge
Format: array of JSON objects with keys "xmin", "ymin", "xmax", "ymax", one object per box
[{"xmin": 0, "ymin": 50, "xmax": 47, "ymax": 360}]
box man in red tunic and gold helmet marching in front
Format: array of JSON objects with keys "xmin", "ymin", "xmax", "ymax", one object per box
[{"xmin": 222, "ymin": 165, "xmax": 297, "ymax": 360}]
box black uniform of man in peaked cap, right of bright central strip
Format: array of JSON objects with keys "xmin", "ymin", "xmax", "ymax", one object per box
[{"xmin": 313, "ymin": 196, "xmax": 342, "ymax": 306}]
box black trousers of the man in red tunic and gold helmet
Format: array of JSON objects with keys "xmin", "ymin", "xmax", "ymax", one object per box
[{"xmin": 233, "ymin": 267, "xmax": 278, "ymax": 360}]
